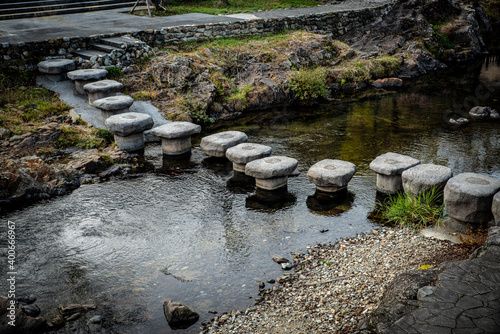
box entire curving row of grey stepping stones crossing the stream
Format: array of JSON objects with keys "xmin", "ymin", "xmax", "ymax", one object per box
[{"xmin": 38, "ymin": 59, "xmax": 500, "ymax": 223}]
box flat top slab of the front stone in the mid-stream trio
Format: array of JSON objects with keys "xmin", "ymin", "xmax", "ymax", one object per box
[{"xmin": 245, "ymin": 156, "xmax": 298, "ymax": 179}]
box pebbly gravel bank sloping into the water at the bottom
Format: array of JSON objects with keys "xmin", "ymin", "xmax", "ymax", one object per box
[{"xmin": 203, "ymin": 228, "xmax": 468, "ymax": 333}]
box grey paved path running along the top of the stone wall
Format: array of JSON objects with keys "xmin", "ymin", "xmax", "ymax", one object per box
[{"xmin": 0, "ymin": 0, "xmax": 391, "ymax": 43}]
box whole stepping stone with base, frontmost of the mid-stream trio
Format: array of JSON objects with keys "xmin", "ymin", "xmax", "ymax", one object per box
[{"xmin": 245, "ymin": 156, "xmax": 298, "ymax": 190}]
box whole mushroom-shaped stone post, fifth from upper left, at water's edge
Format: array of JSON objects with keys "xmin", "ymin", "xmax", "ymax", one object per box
[{"xmin": 105, "ymin": 112, "xmax": 154, "ymax": 152}]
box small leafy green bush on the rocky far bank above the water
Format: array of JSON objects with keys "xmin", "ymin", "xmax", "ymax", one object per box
[{"xmin": 289, "ymin": 67, "xmax": 328, "ymax": 100}]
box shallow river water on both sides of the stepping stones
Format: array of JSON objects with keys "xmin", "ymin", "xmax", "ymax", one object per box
[{"xmin": 1, "ymin": 58, "xmax": 500, "ymax": 333}]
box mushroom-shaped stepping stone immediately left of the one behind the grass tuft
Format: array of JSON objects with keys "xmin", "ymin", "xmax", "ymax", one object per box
[{"xmin": 370, "ymin": 152, "xmax": 420, "ymax": 194}]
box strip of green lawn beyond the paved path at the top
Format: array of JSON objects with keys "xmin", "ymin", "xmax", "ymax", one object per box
[{"xmin": 138, "ymin": 0, "xmax": 320, "ymax": 16}]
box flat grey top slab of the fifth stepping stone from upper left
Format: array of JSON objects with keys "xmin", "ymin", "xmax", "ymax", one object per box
[{"xmin": 105, "ymin": 112, "xmax": 153, "ymax": 137}]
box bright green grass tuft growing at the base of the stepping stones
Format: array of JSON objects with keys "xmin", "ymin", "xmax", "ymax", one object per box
[{"xmin": 380, "ymin": 188, "xmax": 444, "ymax": 229}]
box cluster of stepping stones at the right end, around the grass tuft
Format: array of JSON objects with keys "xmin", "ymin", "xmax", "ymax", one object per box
[{"xmin": 370, "ymin": 153, "xmax": 500, "ymax": 224}]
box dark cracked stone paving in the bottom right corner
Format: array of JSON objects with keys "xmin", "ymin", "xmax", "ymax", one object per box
[{"xmin": 383, "ymin": 227, "xmax": 500, "ymax": 334}]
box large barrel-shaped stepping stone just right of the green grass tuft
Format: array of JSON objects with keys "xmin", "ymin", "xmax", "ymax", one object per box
[{"xmin": 444, "ymin": 173, "xmax": 500, "ymax": 223}]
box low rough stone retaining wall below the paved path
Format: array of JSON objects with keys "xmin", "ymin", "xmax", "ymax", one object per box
[{"xmin": 0, "ymin": 4, "xmax": 392, "ymax": 66}]
